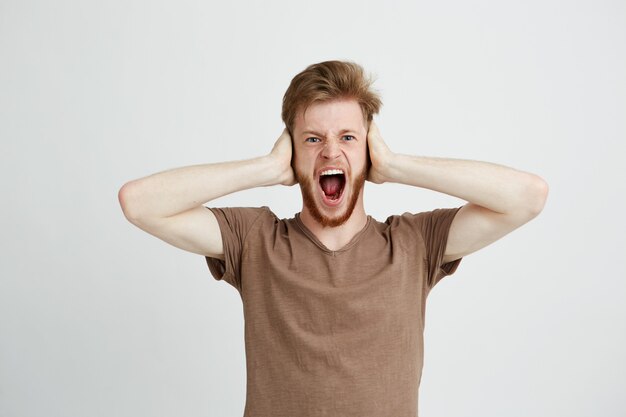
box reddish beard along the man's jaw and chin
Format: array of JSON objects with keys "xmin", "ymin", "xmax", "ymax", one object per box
[{"xmin": 294, "ymin": 167, "xmax": 367, "ymax": 227}]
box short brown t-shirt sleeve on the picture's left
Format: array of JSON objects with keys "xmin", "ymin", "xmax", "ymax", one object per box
[{"xmin": 205, "ymin": 207, "xmax": 268, "ymax": 293}]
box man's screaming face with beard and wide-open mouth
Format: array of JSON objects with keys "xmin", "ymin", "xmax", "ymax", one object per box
[{"xmin": 293, "ymin": 100, "xmax": 368, "ymax": 227}]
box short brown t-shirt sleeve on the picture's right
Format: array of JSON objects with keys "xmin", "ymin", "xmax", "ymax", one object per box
[{"xmin": 413, "ymin": 207, "xmax": 462, "ymax": 289}]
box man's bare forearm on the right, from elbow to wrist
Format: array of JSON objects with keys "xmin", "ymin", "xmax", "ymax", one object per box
[{"xmin": 385, "ymin": 154, "xmax": 547, "ymax": 214}]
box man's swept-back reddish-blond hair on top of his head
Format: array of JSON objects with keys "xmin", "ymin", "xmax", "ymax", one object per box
[{"xmin": 282, "ymin": 61, "xmax": 382, "ymax": 136}]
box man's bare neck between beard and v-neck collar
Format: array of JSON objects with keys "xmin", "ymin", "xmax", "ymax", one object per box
[{"xmin": 300, "ymin": 195, "xmax": 367, "ymax": 250}]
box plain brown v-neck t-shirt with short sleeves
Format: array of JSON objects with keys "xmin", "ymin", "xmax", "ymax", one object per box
[{"xmin": 206, "ymin": 207, "xmax": 461, "ymax": 417}]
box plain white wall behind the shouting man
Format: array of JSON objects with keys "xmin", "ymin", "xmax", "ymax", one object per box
[{"xmin": 0, "ymin": 0, "xmax": 626, "ymax": 417}]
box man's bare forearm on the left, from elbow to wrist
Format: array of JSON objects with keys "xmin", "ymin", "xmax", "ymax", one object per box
[{"xmin": 119, "ymin": 156, "xmax": 280, "ymax": 218}]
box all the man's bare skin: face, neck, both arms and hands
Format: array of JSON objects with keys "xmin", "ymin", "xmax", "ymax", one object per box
[{"xmin": 118, "ymin": 100, "xmax": 548, "ymax": 262}]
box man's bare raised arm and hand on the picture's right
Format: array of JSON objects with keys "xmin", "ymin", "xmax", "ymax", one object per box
[{"xmin": 368, "ymin": 122, "xmax": 548, "ymax": 262}]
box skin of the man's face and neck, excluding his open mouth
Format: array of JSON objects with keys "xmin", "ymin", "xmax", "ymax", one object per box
[{"xmin": 292, "ymin": 100, "xmax": 368, "ymax": 247}]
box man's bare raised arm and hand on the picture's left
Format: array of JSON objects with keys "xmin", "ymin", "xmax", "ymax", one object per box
[{"xmin": 118, "ymin": 129, "xmax": 295, "ymax": 258}]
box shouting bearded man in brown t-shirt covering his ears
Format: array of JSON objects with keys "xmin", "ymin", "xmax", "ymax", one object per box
[{"xmin": 119, "ymin": 61, "xmax": 547, "ymax": 417}]
